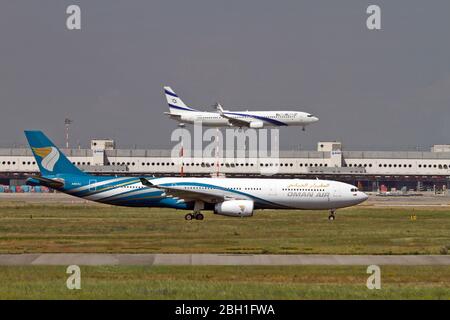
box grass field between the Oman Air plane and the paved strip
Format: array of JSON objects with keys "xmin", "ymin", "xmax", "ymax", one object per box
[{"xmin": 0, "ymin": 202, "xmax": 450, "ymax": 254}]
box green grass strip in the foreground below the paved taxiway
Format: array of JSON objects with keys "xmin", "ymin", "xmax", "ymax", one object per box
[{"xmin": 0, "ymin": 266, "xmax": 450, "ymax": 299}]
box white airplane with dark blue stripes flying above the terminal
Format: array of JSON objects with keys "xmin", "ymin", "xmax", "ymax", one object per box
[{"xmin": 164, "ymin": 86, "xmax": 319, "ymax": 130}]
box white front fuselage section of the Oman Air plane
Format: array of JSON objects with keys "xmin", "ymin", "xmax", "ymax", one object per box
[{"xmin": 146, "ymin": 178, "xmax": 368, "ymax": 210}]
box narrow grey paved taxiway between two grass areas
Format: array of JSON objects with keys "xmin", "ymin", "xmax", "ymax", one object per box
[{"xmin": 0, "ymin": 253, "xmax": 450, "ymax": 266}]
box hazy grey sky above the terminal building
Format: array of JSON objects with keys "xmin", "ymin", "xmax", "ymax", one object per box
[{"xmin": 0, "ymin": 0, "xmax": 450, "ymax": 150}]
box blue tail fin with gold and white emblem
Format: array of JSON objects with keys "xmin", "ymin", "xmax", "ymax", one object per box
[{"xmin": 25, "ymin": 131, "xmax": 85, "ymax": 176}]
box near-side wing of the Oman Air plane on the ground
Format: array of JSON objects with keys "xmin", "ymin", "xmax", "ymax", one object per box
[{"xmin": 140, "ymin": 178, "xmax": 237, "ymax": 203}]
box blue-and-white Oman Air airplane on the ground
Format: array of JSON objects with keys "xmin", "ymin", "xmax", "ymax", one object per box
[{"xmin": 25, "ymin": 131, "xmax": 368, "ymax": 220}]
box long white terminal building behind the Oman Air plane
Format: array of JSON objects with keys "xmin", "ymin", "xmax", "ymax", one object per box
[{"xmin": 0, "ymin": 139, "xmax": 450, "ymax": 191}]
